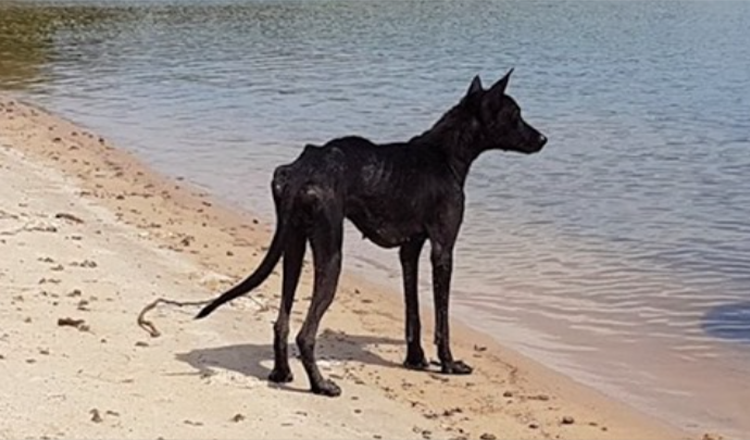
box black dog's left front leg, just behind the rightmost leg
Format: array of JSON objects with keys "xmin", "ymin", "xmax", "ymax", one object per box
[{"xmin": 399, "ymin": 238, "xmax": 429, "ymax": 370}]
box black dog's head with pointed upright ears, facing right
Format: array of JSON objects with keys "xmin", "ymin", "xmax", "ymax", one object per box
[{"xmin": 461, "ymin": 69, "xmax": 547, "ymax": 154}]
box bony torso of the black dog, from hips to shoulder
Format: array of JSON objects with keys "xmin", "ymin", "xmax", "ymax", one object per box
[{"xmin": 274, "ymin": 136, "xmax": 461, "ymax": 247}]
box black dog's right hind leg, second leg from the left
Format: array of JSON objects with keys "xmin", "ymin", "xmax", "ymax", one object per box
[{"xmin": 297, "ymin": 200, "xmax": 344, "ymax": 397}]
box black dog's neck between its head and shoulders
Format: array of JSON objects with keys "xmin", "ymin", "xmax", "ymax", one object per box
[{"xmin": 410, "ymin": 104, "xmax": 488, "ymax": 187}]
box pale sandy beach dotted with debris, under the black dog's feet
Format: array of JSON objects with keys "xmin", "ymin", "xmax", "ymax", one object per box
[{"xmin": 0, "ymin": 95, "xmax": 700, "ymax": 440}]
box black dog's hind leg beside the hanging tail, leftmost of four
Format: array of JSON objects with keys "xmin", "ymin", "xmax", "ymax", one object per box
[{"xmin": 268, "ymin": 227, "xmax": 307, "ymax": 383}]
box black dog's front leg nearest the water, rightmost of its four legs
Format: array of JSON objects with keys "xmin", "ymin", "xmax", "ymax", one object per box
[{"xmin": 431, "ymin": 240, "xmax": 472, "ymax": 374}]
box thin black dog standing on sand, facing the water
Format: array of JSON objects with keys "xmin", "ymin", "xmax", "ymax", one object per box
[{"xmin": 197, "ymin": 70, "xmax": 547, "ymax": 396}]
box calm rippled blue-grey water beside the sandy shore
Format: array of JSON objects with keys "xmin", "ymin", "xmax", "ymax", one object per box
[{"xmin": 0, "ymin": 0, "xmax": 750, "ymax": 435}]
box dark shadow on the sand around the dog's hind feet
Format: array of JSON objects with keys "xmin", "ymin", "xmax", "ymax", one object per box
[{"xmin": 175, "ymin": 330, "xmax": 403, "ymax": 391}]
